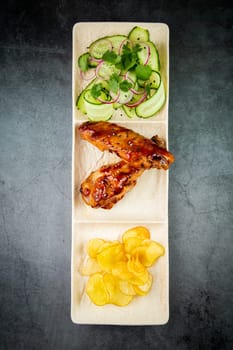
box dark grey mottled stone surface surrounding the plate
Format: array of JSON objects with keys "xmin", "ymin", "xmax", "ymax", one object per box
[{"xmin": 0, "ymin": 0, "xmax": 233, "ymax": 350}]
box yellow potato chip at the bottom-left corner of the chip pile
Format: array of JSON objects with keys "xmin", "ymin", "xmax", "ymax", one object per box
[{"xmin": 86, "ymin": 273, "xmax": 109, "ymax": 306}]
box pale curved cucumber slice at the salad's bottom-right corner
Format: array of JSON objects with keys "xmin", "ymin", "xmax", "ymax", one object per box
[{"xmin": 135, "ymin": 80, "xmax": 166, "ymax": 118}]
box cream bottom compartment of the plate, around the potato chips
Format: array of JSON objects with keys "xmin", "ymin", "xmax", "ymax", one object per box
[{"xmin": 71, "ymin": 222, "xmax": 169, "ymax": 325}]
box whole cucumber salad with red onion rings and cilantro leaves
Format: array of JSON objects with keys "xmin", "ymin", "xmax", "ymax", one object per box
[{"xmin": 76, "ymin": 26, "xmax": 166, "ymax": 121}]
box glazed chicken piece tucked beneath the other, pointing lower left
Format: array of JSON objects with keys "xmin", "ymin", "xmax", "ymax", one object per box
[{"xmin": 80, "ymin": 160, "xmax": 144, "ymax": 209}]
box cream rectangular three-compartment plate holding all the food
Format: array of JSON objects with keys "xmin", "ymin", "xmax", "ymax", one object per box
[{"xmin": 71, "ymin": 22, "xmax": 169, "ymax": 325}]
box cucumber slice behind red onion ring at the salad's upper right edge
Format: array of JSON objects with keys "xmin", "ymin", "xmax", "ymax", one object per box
[{"xmin": 137, "ymin": 41, "xmax": 160, "ymax": 72}]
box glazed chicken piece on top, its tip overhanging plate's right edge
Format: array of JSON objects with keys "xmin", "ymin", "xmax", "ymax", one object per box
[{"xmin": 79, "ymin": 122, "xmax": 175, "ymax": 170}]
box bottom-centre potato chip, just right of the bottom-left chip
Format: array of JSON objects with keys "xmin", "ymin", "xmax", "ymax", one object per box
[{"xmin": 103, "ymin": 273, "xmax": 133, "ymax": 306}]
